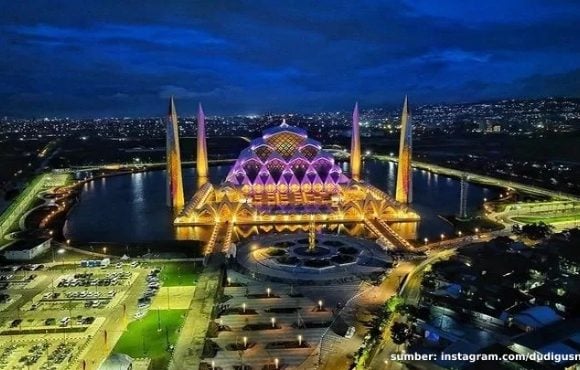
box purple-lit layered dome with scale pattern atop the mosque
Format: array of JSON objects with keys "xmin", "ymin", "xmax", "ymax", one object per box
[{"xmin": 226, "ymin": 121, "xmax": 350, "ymax": 193}]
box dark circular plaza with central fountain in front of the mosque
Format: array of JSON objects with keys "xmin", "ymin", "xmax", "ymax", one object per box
[{"xmin": 236, "ymin": 233, "xmax": 392, "ymax": 283}]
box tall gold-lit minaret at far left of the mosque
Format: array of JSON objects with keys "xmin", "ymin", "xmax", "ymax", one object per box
[{"xmin": 166, "ymin": 96, "xmax": 185, "ymax": 209}]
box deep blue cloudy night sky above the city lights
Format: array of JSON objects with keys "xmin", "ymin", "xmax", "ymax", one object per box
[{"xmin": 0, "ymin": 0, "xmax": 580, "ymax": 117}]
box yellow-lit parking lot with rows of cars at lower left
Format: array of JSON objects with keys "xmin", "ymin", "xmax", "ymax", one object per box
[{"xmin": 0, "ymin": 263, "xmax": 155, "ymax": 370}]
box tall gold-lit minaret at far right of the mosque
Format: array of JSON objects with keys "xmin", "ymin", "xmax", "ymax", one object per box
[{"xmin": 395, "ymin": 95, "xmax": 413, "ymax": 203}]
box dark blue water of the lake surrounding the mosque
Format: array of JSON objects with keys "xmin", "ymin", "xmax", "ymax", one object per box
[{"xmin": 66, "ymin": 160, "xmax": 498, "ymax": 242}]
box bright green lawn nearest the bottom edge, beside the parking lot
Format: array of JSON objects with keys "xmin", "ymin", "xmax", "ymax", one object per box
[{"xmin": 113, "ymin": 310, "xmax": 186, "ymax": 369}]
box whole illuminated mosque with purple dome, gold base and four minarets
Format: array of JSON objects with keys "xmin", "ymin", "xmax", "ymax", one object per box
[{"xmin": 167, "ymin": 98, "xmax": 420, "ymax": 253}]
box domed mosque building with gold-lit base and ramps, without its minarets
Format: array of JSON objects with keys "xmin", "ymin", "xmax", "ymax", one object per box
[{"xmin": 174, "ymin": 118, "xmax": 419, "ymax": 252}]
